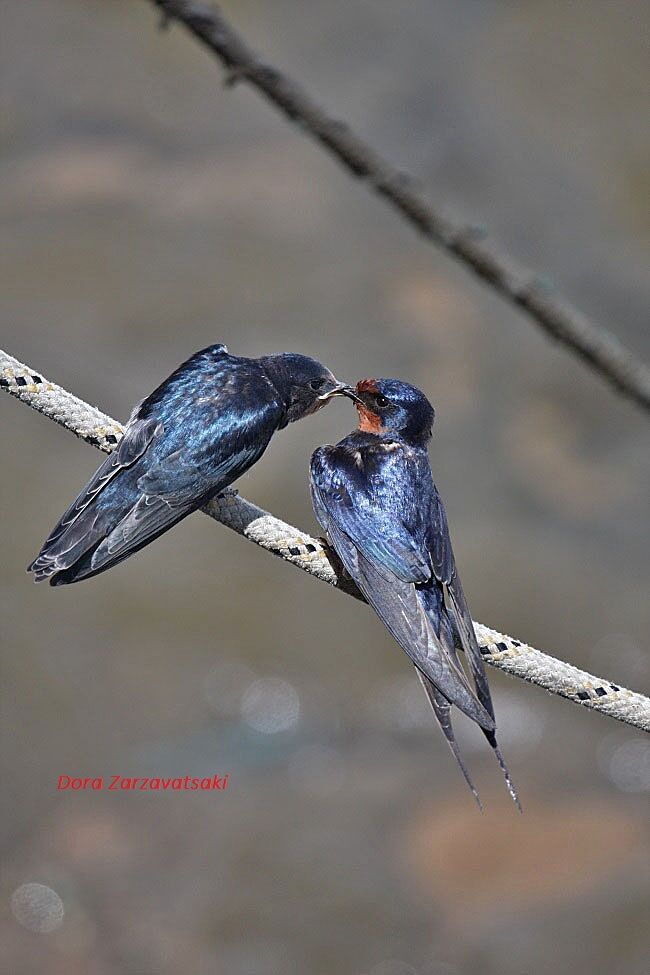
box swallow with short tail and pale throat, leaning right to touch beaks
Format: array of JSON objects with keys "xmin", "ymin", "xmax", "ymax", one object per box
[{"xmin": 27, "ymin": 345, "xmax": 347, "ymax": 586}]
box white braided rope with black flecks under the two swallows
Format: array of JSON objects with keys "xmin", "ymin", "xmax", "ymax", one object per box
[{"xmin": 0, "ymin": 350, "xmax": 650, "ymax": 731}]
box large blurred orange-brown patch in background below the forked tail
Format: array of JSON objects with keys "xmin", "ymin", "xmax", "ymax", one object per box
[{"xmin": 406, "ymin": 792, "xmax": 650, "ymax": 923}]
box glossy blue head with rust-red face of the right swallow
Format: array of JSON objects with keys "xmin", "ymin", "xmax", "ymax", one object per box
[{"xmin": 346, "ymin": 379, "xmax": 434, "ymax": 444}]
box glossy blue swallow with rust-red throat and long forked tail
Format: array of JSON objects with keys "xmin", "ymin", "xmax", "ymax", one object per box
[{"xmin": 311, "ymin": 379, "xmax": 521, "ymax": 811}]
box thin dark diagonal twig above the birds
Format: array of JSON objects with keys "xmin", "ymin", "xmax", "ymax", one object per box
[{"xmin": 146, "ymin": 0, "xmax": 650, "ymax": 410}]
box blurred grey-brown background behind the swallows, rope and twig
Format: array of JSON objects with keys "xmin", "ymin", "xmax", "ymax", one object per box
[{"xmin": 0, "ymin": 0, "xmax": 650, "ymax": 975}]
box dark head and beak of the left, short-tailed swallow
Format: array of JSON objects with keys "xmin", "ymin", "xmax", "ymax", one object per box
[{"xmin": 260, "ymin": 352, "xmax": 349, "ymax": 423}]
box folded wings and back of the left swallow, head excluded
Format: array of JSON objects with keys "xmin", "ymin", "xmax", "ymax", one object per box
[{"xmin": 28, "ymin": 368, "xmax": 279, "ymax": 586}]
